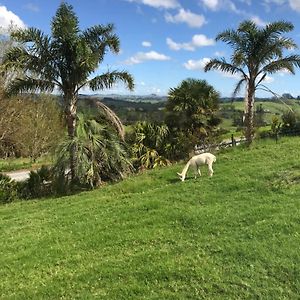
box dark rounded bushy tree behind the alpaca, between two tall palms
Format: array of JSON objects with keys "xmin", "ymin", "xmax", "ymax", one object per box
[{"xmin": 166, "ymin": 78, "xmax": 220, "ymax": 155}]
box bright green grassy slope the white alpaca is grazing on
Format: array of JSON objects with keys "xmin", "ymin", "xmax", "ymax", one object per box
[{"xmin": 0, "ymin": 138, "xmax": 300, "ymax": 299}]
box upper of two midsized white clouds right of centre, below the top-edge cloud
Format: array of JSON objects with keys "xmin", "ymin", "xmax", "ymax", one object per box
[{"xmin": 165, "ymin": 8, "xmax": 206, "ymax": 27}]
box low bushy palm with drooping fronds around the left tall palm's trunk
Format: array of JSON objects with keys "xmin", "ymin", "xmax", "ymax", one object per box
[{"xmin": 54, "ymin": 115, "xmax": 130, "ymax": 188}]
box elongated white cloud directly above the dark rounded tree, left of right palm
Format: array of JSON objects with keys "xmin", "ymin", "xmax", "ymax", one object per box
[{"xmin": 166, "ymin": 34, "xmax": 215, "ymax": 51}]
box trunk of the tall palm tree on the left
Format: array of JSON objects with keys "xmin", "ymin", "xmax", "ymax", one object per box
[{"xmin": 64, "ymin": 93, "xmax": 77, "ymax": 182}]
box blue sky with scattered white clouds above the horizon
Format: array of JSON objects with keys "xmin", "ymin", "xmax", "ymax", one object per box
[{"xmin": 0, "ymin": 0, "xmax": 300, "ymax": 97}]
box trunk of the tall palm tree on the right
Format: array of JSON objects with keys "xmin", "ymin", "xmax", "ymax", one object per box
[{"xmin": 245, "ymin": 83, "xmax": 255, "ymax": 145}]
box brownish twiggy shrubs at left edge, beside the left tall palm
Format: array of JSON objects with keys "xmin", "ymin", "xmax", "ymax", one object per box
[{"xmin": 0, "ymin": 95, "xmax": 65, "ymax": 161}]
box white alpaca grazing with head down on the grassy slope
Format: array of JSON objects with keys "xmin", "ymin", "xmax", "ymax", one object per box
[{"xmin": 177, "ymin": 153, "xmax": 216, "ymax": 181}]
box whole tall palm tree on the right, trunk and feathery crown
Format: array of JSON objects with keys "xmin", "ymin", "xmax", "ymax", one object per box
[{"xmin": 205, "ymin": 21, "xmax": 300, "ymax": 144}]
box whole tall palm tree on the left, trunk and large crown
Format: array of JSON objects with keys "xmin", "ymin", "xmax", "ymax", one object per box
[{"xmin": 4, "ymin": 2, "xmax": 134, "ymax": 181}]
